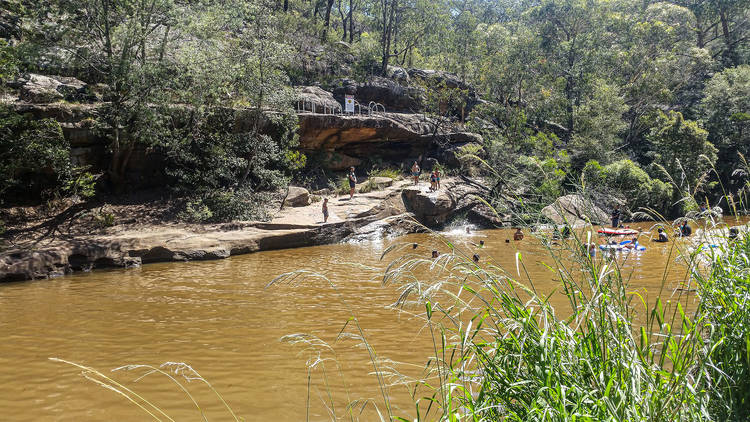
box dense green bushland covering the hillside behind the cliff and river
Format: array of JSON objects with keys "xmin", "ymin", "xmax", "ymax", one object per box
[{"xmin": 0, "ymin": 0, "xmax": 750, "ymax": 215}]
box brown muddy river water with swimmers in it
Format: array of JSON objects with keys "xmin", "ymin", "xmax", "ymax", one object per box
[{"xmin": 0, "ymin": 224, "xmax": 720, "ymax": 422}]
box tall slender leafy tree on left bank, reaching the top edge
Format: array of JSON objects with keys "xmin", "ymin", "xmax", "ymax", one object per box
[{"xmin": 57, "ymin": 0, "xmax": 176, "ymax": 188}]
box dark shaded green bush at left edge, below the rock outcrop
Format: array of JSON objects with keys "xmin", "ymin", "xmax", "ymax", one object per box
[{"xmin": 0, "ymin": 106, "xmax": 71, "ymax": 202}]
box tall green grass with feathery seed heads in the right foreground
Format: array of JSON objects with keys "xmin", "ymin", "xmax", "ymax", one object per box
[{"xmin": 50, "ymin": 163, "xmax": 750, "ymax": 421}]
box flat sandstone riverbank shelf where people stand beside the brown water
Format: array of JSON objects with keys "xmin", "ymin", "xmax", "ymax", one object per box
[{"xmin": 0, "ymin": 178, "xmax": 501, "ymax": 281}]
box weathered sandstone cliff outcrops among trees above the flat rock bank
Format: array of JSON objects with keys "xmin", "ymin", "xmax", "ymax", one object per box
[{"xmin": 4, "ymin": 71, "xmax": 482, "ymax": 185}]
